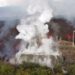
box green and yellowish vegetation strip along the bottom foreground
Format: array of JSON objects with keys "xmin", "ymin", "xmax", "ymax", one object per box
[{"xmin": 0, "ymin": 61, "xmax": 75, "ymax": 75}]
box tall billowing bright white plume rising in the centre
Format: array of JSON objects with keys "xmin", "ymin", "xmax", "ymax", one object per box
[{"xmin": 7, "ymin": 0, "xmax": 60, "ymax": 67}]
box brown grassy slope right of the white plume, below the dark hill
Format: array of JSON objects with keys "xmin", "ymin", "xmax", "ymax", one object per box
[{"xmin": 59, "ymin": 41, "xmax": 75, "ymax": 63}]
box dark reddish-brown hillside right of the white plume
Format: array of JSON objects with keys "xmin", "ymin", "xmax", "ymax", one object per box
[{"xmin": 49, "ymin": 18, "xmax": 75, "ymax": 41}]
